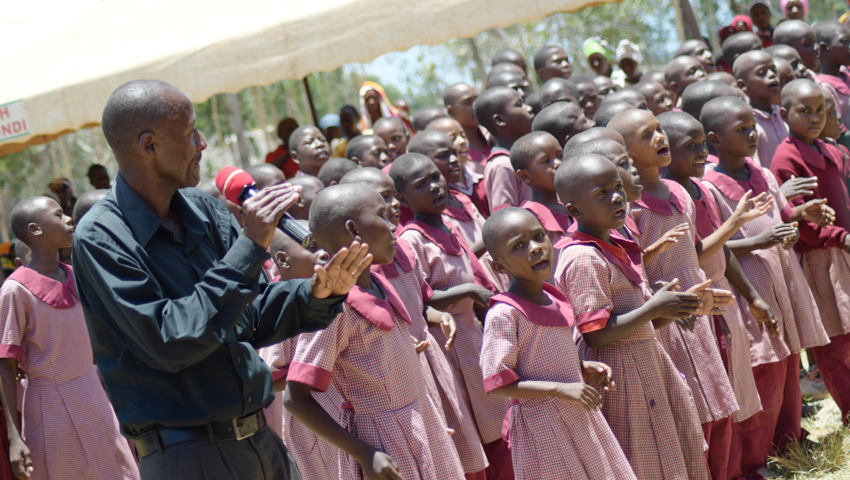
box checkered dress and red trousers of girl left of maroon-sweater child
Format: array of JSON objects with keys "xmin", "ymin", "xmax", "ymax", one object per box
[{"xmin": 703, "ymin": 159, "xmax": 829, "ymax": 475}]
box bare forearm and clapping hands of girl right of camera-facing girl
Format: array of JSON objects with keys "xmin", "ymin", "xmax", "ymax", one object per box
[{"xmin": 582, "ymin": 279, "xmax": 700, "ymax": 348}]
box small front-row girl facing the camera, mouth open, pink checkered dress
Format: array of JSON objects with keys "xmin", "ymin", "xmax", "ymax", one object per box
[{"xmin": 481, "ymin": 207, "xmax": 635, "ymax": 480}]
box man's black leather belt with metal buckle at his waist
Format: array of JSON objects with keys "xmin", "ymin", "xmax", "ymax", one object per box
[{"xmin": 134, "ymin": 410, "xmax": 266, "ymax": 459}]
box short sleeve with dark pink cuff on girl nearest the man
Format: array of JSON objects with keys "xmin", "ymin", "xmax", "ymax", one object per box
[{"xmin": 286, "ymin": 308, "xmax": 357, "ymax": 392}]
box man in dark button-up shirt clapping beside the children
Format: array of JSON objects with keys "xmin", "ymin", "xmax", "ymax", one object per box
[{"xmin": 74, "ymin": 80, "xmax": 371, "ymax": 480}]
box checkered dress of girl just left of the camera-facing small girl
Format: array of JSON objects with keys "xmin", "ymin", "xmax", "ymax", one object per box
[{"xmin": 399, "ymin": 222, "xmax": 508, "ymax": 444}]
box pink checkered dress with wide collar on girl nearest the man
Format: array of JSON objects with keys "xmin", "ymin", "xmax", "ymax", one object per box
[{"xmin": 287, "ymin": 275, "xmax": 463, "ymax": 480}]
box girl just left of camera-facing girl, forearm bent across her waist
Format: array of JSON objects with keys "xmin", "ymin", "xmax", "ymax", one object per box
[{"xmin": 390, "ymin": 153, "xmax": 512, "ymax": 478}]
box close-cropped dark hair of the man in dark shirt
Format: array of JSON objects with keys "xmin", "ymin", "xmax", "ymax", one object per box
[{"xmin": 101, "ymin": 80, "xmax": 187, "ymax": 161}]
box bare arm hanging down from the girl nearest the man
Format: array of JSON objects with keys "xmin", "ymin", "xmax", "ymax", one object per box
[{"xmin": 283, "ymin": 382, "xmax": 402, "ymax": 480}]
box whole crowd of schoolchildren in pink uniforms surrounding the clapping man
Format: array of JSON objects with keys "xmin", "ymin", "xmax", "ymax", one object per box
[{"xmin": 0, "ymin": 0, "xmax": 850, "ymax": 480}]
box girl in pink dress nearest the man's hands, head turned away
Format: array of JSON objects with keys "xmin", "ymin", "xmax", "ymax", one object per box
[{"xmin": 284, "ymin": 184, "xmax": 464, "ymax": 480}]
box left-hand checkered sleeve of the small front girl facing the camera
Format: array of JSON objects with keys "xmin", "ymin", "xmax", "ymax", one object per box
[{"xmin": 480, "ymin": 303, "xmax": 520, "ymax": 392}]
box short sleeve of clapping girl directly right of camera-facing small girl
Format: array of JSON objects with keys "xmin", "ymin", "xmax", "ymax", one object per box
[{"xmin": 556, "ymin": 246, "xmax": 614, "ymax": 333}]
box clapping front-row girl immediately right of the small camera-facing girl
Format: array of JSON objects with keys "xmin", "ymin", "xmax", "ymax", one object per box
[{"xmin": 555, "ymin": 154, "xmax": 708, "ymax": 479}]
